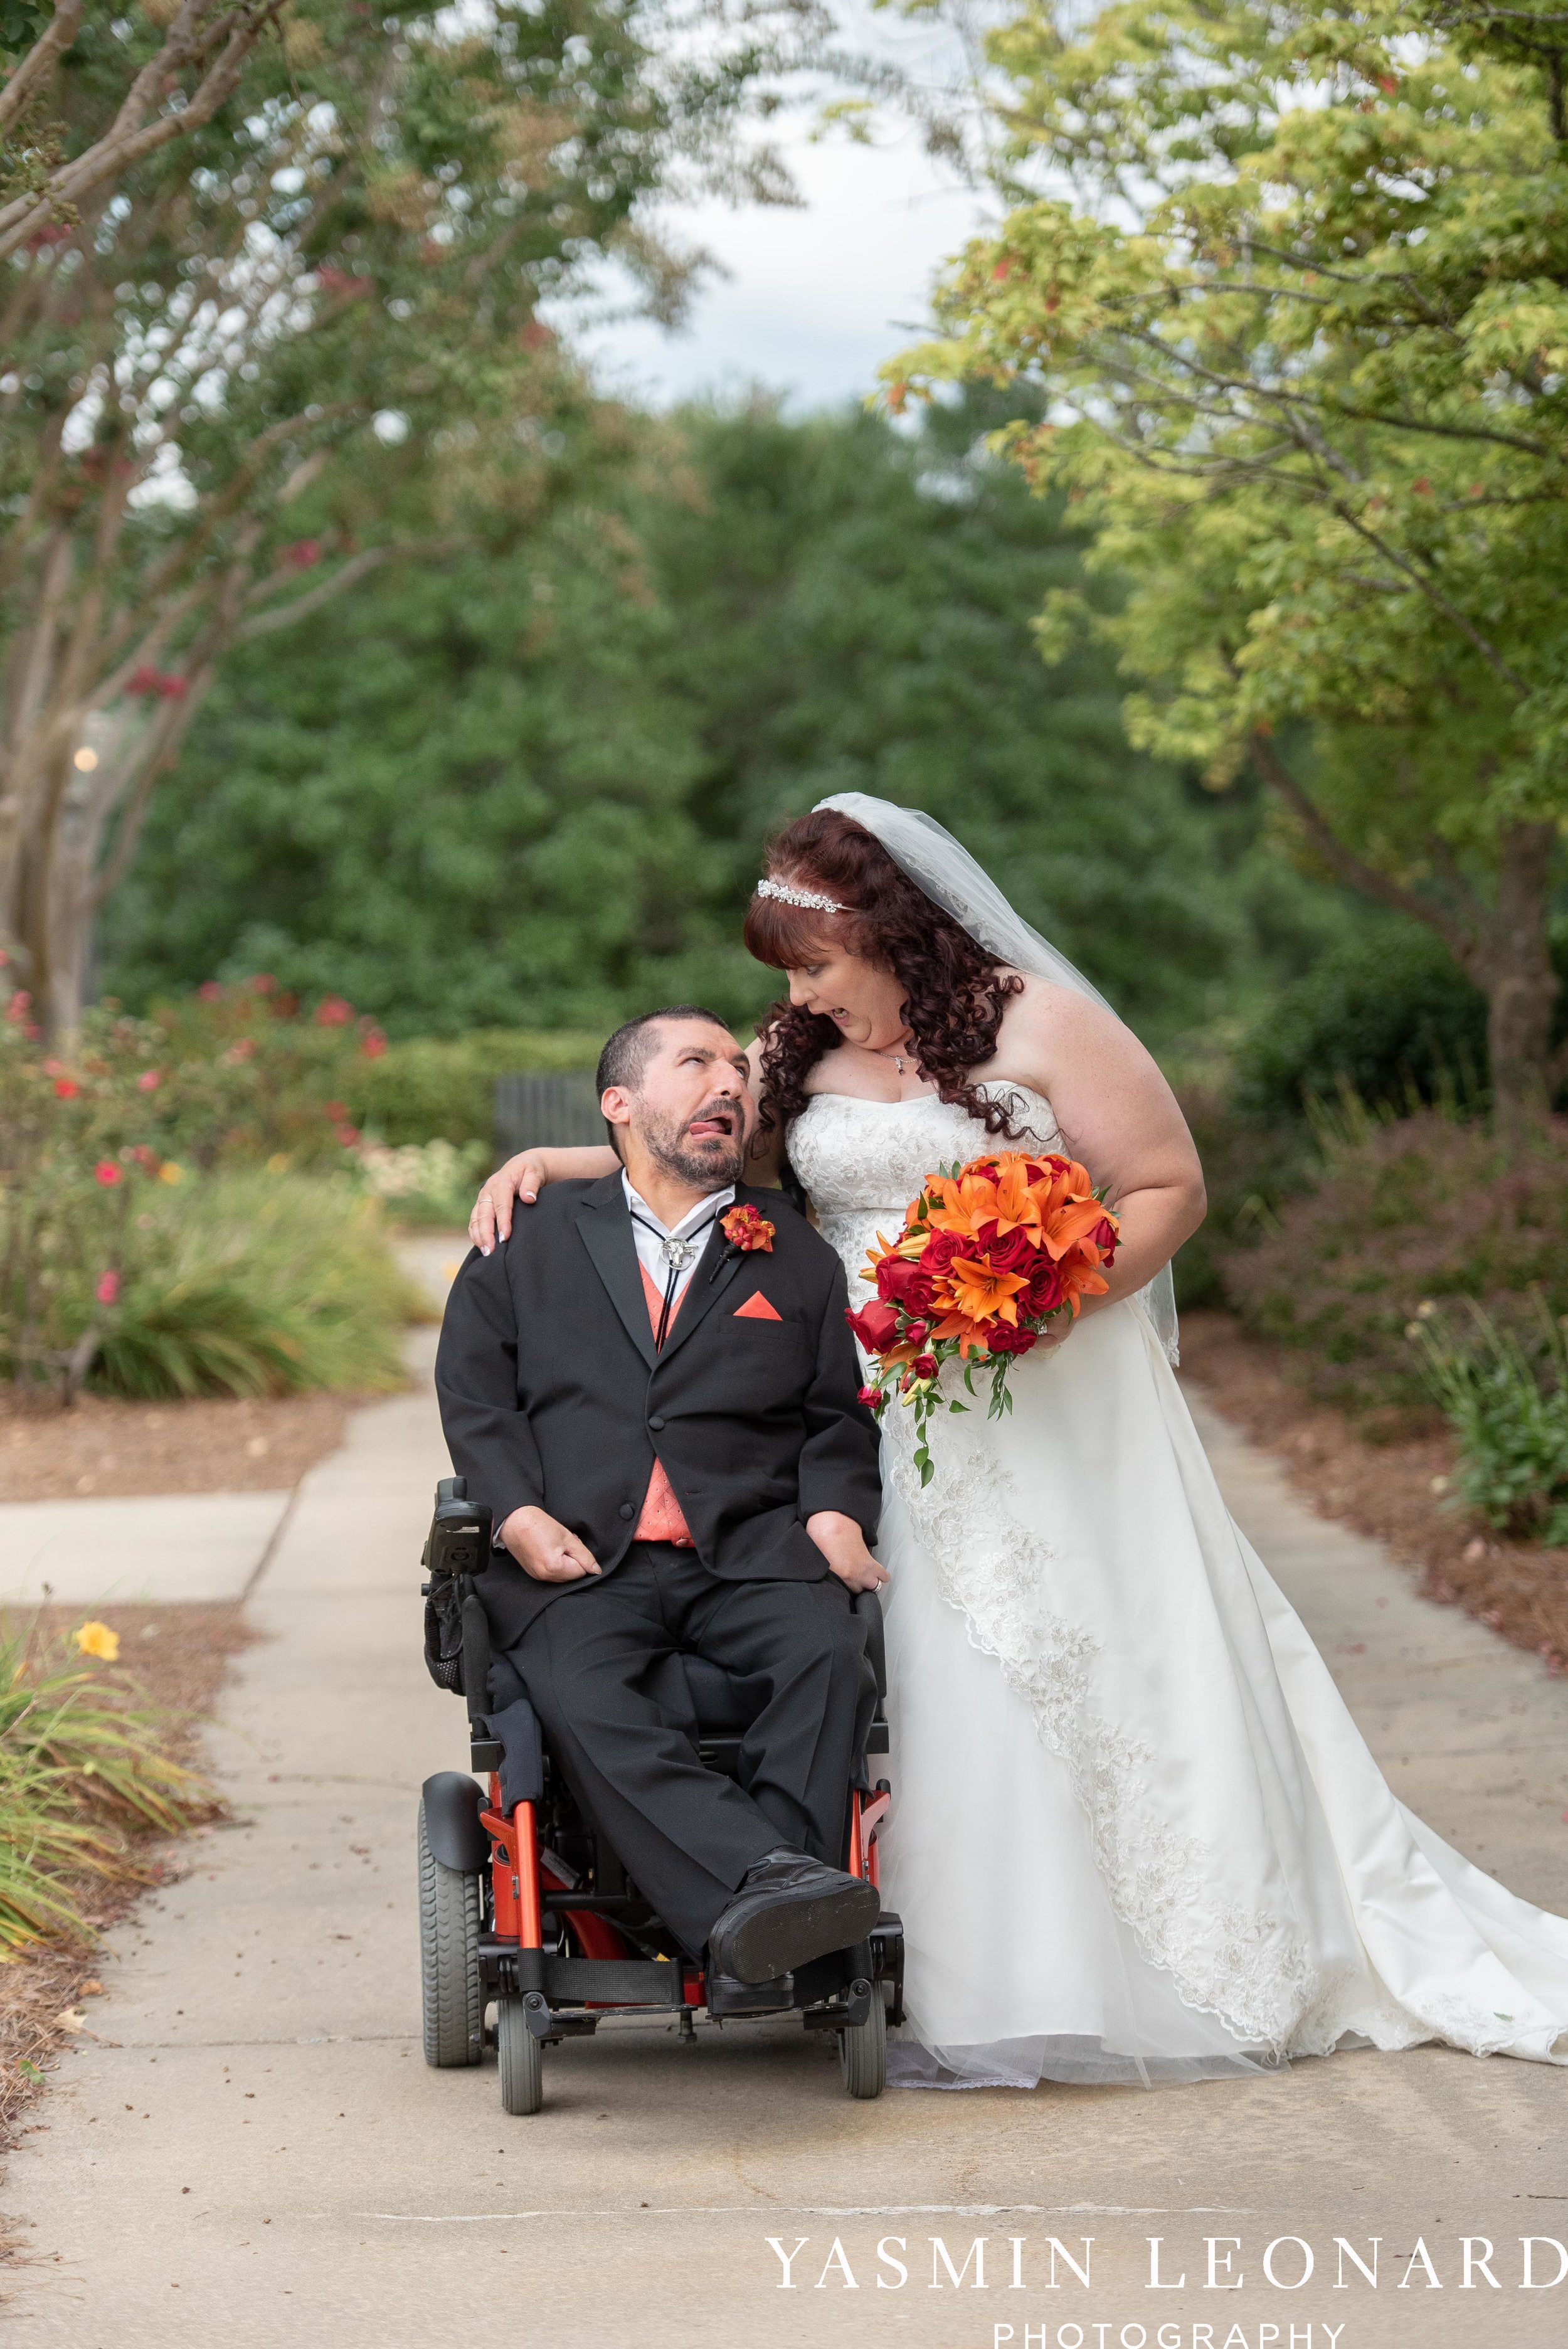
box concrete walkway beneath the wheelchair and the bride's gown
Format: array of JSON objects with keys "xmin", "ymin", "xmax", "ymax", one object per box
[{"xmin": 4, "ymin": 1334, "xmax": 1568, "ymax": 2349}]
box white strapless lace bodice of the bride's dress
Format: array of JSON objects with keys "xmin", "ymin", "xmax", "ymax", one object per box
[{"xmin": 788, "ymin": 1078, "xmax": 1061, "ymax": 1299}]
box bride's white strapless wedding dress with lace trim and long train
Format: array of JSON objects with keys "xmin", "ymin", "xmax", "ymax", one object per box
[{"xmin": 788, "ymin": 1088, "xmax": 1568, "ymax": 2088}]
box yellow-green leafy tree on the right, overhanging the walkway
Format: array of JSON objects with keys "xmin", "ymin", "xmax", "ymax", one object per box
[{"xmin": 889, "ymin": 0, "xmax": 1568, "ymax": 1137}]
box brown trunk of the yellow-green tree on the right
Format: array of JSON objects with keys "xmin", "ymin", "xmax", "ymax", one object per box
[{"xmin": 1470, "ymin": 824, "xmax": 1559, "ymax": 1148}]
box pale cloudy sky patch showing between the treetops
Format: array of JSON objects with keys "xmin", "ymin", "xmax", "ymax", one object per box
[{"xmin": 554, "ymin": 7, "xmax": 981, "ymax": 411}]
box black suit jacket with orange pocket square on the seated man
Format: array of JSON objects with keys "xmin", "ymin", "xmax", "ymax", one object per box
[{"xmin": 437, "ymin": 1175, "xmax": 880, "ymax": 1645}]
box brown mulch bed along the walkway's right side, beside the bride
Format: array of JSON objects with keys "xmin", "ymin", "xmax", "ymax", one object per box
[{"xmin": 1180, "ymin": 1313, "xmax": 1568, "ymax": 1675}]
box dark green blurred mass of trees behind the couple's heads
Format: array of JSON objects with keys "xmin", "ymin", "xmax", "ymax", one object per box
[{"xmin": 105, "ymin": 401, "xmax": 1345, "ymax": 1036}]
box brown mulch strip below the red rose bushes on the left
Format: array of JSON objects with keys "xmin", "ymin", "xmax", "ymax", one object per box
[{"xmin": 0, "ymin": 1388, "xmax": 354, "ymax": 1501}]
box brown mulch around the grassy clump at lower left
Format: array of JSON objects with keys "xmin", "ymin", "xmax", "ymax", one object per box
[{"xmin": 0, "ymin": 1597, "xmax": 256, "ymax": 2161}]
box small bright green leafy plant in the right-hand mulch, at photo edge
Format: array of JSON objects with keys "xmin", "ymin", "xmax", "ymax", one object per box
[{"xmin": 1409, "ymin": 1302, "xmax": 1568, "ymax": 1543}]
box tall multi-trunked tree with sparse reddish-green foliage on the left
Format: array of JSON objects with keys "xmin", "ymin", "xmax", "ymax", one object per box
[{"xmin": 0, "ymin": 0, "xmax": 810, "ymax": 1031}]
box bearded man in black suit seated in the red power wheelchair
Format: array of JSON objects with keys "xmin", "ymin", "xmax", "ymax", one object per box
[{"xmin": 437, "ymin": 1005, "xmax": 892, "ymax": 2109}]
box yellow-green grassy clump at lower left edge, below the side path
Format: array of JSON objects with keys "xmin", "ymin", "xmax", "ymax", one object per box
[{"xmin": 0, "ymin": 1618, "xmax": 221, "ymax": 1949}]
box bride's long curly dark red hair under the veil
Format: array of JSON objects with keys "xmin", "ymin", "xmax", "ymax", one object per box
[{"xmin": 744, "ymin": 808, "xmax": 1024, "ymax": 1137}]
